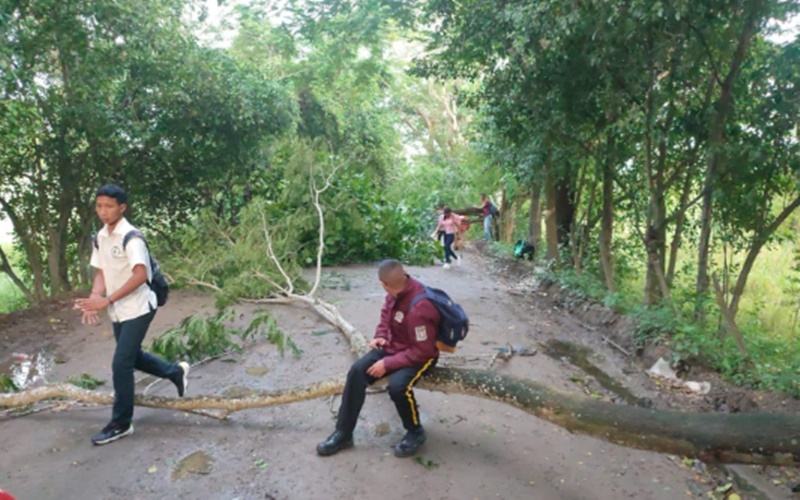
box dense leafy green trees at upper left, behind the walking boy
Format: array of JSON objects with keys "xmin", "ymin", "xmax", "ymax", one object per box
[{"xmin": 0, "ymin": 0, "xmax": 295, "ymax": 300}]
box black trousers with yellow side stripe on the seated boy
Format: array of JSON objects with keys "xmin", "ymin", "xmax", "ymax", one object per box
[{"xmin": 336, "ymin": 349, "xmax": 437, "ymax": 434}]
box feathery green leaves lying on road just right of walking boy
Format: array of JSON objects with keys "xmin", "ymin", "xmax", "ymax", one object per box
[{"xmin": 149, "ymin": 308, "xmax": 302, "ymax": 363}]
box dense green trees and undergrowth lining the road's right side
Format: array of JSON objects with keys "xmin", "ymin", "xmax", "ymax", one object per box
[{"xmin": 409, "ymin": 0, "xmax": 800, "ymax": 392}]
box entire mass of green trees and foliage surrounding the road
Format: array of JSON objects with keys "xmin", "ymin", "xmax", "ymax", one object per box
[{"xmin": 0, "ymin": 0, "xmax": 800, "ymax": 391}]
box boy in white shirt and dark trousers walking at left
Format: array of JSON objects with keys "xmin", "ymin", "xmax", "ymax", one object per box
[{"xmin": 75, "ymin": 185, "xmax": 189, "ymax": 445}]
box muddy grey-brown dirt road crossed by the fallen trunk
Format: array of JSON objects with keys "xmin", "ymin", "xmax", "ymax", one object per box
[{"xmin": 0, "ymin": 247, "xmax": 791, "ymax": 500}]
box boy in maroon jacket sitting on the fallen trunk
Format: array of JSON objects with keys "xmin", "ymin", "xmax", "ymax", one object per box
[{"xmin": 317, "ymin": 259, "xmax": 440, "ymax": 457}]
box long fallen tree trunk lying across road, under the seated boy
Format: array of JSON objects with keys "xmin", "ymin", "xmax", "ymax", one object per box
[{"xmin": 0, "ymin": 368, "xmax": 800, "ymax": 465}]
